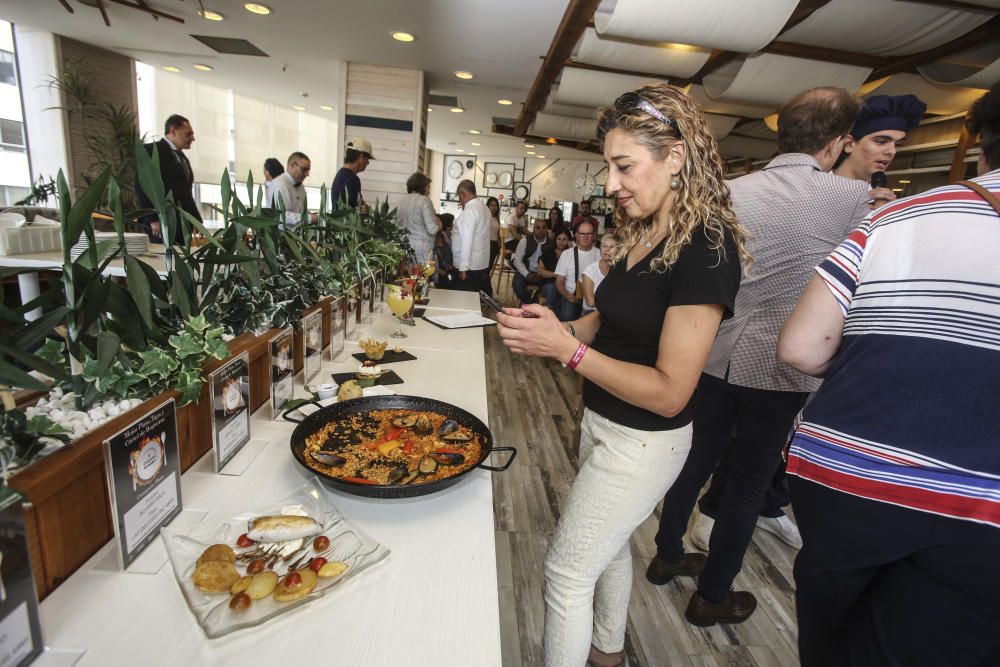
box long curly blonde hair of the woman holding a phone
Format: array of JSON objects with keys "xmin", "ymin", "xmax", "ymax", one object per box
[{"xmin": 597, "ymin": 83, "xmax": 752, "ymax": 271}]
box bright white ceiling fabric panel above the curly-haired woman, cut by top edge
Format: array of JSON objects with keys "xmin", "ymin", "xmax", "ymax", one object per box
[{"xmin": 594, "ymin": 0, "xmax": 799, "ymax": 53}]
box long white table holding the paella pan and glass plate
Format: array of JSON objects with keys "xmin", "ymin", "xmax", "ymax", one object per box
[{"xmin": 42, "ymin": 293, "xmax": 501, "ymax": 667}]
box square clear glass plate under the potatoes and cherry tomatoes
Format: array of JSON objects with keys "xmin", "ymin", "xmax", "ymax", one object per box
[{"xmin": 162, "ymin": 477, "xmax": 389, "ymax": 638}]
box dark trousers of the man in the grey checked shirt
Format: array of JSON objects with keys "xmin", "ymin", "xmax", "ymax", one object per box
[{"xmin": 656, "ymin": 374, "xmax": 808, "ymax": 603}]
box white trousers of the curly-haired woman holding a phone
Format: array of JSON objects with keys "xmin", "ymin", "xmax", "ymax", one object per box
[{"xmin": 545, "ymin": 410, "xmax": 691, "ymax": 667}]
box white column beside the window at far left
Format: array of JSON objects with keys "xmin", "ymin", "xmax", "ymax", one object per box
[{"xmin": 14, "ymin": 25, "xmax": 72, "ymax": 187}]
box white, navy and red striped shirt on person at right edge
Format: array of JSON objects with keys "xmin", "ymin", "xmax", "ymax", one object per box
[{"xmin": 788, "ymin": 170, "xmax": 1000, "ymax": 527}]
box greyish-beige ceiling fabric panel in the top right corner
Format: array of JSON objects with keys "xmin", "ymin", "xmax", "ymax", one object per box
[{"xmin": 781, "ymin": 0, "xmax": 993, "ymax": 56}]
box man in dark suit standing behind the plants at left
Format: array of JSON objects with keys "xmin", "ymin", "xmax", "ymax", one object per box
[{"xmin": 135, "ymin": 114, "xmax": 201, "ymax": 243}]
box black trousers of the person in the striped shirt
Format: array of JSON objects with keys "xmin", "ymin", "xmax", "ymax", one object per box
[{"xmin": 791, "ymin": 477, "xmax": 1000, "ymax": 667}]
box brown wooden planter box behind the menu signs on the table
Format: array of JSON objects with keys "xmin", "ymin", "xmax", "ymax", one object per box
[{"xmin": 10, "ymin": 331, "xmax": 275, "ymax": 598}]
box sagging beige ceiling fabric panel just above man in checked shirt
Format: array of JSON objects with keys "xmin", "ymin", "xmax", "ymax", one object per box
[{"xmin": 702, "ymin": 53, "xmax": 872, "ymax": 106}]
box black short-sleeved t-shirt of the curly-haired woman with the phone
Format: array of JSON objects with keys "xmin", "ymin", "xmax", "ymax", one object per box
[{"xmin": 583, "ymin": 229, "xmax": 741, "ymax": 431}]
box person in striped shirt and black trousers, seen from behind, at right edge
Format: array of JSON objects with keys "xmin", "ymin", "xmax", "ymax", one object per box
[{"xmin": 778, "ymin": 84, "xmax": 1000, "ymax": 667}]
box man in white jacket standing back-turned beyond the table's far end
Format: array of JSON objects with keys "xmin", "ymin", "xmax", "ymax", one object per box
[{"xmin": 451, "ymin": 179, "xmax": 493, "ymax": 295}]
